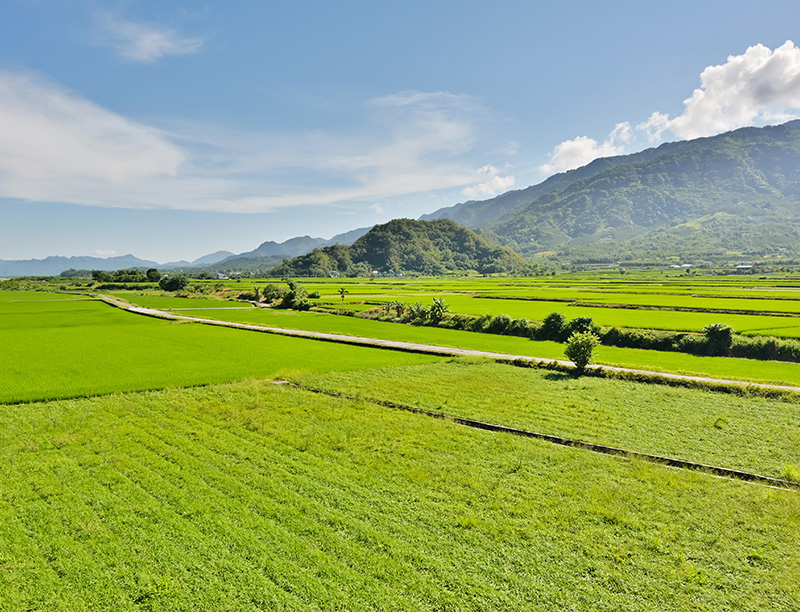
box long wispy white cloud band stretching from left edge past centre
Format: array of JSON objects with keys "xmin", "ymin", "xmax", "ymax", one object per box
[{"xmin": 0, "ymin": 71, "xmax": 488, "ymax": 214}]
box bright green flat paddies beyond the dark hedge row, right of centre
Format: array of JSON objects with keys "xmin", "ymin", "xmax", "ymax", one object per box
[{"xmin": 286, "ymin": 275, "xmax": 800, "ymax": 338}]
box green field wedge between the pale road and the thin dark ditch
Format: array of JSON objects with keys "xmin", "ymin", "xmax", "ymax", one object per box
[{"xmin": 298, "ymin": 360, "xmax": 800, "ymax": 478}]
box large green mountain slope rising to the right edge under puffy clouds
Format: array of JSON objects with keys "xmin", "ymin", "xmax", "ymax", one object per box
[{"xmin": 424, "ymin": 121, "xmax": 800, "ymax": 259}]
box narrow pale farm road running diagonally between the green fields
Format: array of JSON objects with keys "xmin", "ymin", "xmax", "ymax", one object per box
[{"xmin": 97, "ymin": 295, "xmax": 800, "ymax": 393}]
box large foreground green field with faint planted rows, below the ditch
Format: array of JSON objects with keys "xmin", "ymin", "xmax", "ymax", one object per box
[{"xmin": 0, "ymin": 382, "xmax": 800, "ymax": 611}]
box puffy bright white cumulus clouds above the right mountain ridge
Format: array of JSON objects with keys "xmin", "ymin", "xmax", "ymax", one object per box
[{"xmin": 540, "ymin": 40, "xmax": 800, "ymax": 174}]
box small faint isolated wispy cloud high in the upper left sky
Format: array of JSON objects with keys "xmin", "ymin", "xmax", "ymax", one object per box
[{"xmin": 97, "ymin": 12, "xmax": 203, "ymax": 63}]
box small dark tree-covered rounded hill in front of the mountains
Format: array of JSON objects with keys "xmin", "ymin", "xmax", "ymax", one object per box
[{"xmin": 273, "ymin": 219, "xmax": 525, "ymax": 276}]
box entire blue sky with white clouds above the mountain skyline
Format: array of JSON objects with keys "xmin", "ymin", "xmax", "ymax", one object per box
[{"xmin": 0, "ymin": 0, "xmax": 800, "ymax": 263}]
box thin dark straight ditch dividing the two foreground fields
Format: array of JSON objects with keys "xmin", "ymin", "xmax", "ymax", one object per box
[{"xmin": 282, "ymin": 380, "xmax": 800, "ymax": 491}]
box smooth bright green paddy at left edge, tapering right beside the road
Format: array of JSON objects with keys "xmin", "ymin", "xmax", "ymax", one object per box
[{"xmin": 0, "ymin": 293, "xmax": 435, "ymax": 402}]
